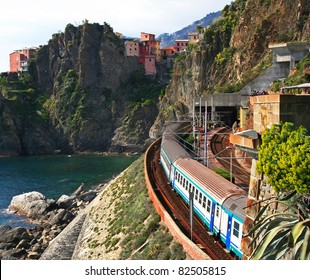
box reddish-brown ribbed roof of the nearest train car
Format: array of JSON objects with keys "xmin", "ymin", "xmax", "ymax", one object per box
[{"xmin": 175, "ymin": 158, "xmax": 246, "ymax": 206}]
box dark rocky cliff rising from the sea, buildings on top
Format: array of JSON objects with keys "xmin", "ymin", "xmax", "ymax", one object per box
[{"xmin": 0, "ymin": 22, "xmax": 165, "ymax": 155}]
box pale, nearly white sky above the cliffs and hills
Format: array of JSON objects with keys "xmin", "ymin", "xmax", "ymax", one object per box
[{"xmin": 0, "ymin": 0, "xmax": 232, "ymax": 72}]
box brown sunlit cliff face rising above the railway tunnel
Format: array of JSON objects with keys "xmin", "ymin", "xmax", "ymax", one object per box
[{"xmin": 150, "ymin": 0, "xmax": 310, "ymax": 138}]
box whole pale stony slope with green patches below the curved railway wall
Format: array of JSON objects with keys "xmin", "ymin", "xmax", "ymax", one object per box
[{"xmin": 72, "ymin": 156, "xmax": 186, "ymax": 260}]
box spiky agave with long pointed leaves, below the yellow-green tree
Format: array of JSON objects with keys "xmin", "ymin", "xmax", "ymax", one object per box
[{"xmin": 248, "ymin": 191, "xmax": 310, "ymax": 260}]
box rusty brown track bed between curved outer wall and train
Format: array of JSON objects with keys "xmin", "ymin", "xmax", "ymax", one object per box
[{"xmin": 147, "ymin": 141, "xmax": 234, "ymax": 260}]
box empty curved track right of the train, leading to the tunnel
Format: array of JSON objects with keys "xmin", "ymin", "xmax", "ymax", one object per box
[{"xmin": 210, "ymin": 129, "xmax": 250, "ymax": 189}]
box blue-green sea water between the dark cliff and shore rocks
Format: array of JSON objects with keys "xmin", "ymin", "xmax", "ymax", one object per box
[{"xmin": 0, "ymin": 154, "xmax": 138, "ymax": 228}]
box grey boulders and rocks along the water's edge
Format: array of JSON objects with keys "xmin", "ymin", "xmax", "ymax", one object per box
[{"xmin": 0, "ymin": 184, "xmax": 106, "ymax": 260}]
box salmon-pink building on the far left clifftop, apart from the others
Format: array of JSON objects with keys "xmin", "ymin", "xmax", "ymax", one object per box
[{"xmin": 10, "ymin": 48, "xmax": 36, "ymax": 72}]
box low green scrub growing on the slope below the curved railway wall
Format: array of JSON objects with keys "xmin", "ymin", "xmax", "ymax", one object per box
[{"xmin": 88, "ymin": 156, "xmax": 186, "ymax": 260}]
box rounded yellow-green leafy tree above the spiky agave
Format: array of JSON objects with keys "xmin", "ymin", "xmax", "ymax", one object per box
[{"xmin": 257, "ymin": 122, "xmax": 310, "ymax": 194}]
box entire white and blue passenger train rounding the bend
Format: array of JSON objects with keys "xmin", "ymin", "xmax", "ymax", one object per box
[{"xmin": 160, "ymin": 123, "xmax": 247, "ymax": 258}]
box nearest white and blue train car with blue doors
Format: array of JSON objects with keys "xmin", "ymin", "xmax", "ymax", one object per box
[{"xmin": 170, "ymin": 158, "xmax": 247, "ymax": 258}]
